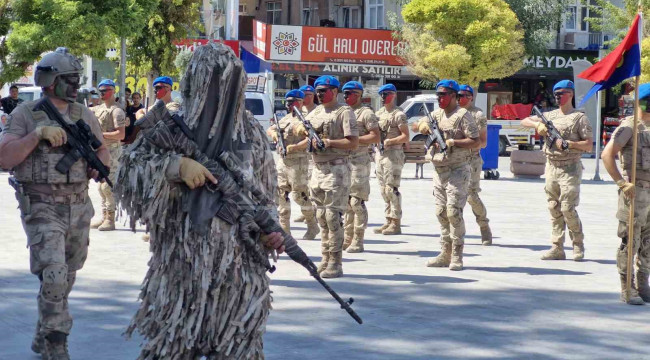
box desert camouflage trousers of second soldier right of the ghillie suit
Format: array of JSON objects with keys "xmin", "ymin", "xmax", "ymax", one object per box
[{"xmin": 309, "ymin": 159, "xmax": 350, "ymax": 254}]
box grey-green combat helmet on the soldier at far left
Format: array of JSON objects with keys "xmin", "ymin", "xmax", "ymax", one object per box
[{"xmin": 34, "ymin": 47, "xmax": 83, "ymax": 87}]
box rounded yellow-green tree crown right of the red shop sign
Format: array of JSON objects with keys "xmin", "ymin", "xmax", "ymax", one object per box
[{"xmin": 399, "ymin": 0, "xmax": 524, "ymax": 86}]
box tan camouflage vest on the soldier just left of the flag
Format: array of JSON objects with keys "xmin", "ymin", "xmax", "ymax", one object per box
[{"xmin": 544, "ymin": 109, "xmax": 583, "ymax": 162}]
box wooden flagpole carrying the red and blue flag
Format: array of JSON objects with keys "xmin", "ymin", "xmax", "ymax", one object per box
[{"xmin": 625, "ymin": 6, "xmax": 643, "ymax": 301}]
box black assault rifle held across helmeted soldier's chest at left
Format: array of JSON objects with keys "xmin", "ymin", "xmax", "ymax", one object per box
[{"xmin": 34, "ymin": 96, "xmax": 113, "ymax": 187}]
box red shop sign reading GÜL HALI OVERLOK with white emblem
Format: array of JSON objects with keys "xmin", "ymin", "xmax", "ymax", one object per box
[{"xmin": 253, "ymin": 21, "xmax": 405, "ymax": 66}]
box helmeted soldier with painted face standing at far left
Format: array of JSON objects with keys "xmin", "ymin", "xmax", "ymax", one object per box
[{"xmin": 0, "ymin": 48, "xmax": 109, "ymax": 360}]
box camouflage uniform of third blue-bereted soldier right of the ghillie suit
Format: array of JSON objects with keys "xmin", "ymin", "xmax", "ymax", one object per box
[{"xmin": 344, "ymin": 105, "xmax": 379, "ymax": 252}]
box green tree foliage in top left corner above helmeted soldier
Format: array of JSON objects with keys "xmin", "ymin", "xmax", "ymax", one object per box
[{"xmin": 0, "ymin": 0, "xmax": 159, "ymax": 86}]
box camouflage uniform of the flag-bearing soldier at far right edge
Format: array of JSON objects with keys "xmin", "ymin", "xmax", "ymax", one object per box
[{"xmin": 611, "ymin": 116, "xmax": 650, "ymax": 302}]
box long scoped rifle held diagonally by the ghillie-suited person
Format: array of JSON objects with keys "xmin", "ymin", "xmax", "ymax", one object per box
[{"xmin": 138, "ymin": 100, "xmax": 363, "ymax": 324}]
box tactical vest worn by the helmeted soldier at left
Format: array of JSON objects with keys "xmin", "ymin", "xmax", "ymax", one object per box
[{"xmin": 14, "ymin": 101, "xmax": 88, "ymax": 184}]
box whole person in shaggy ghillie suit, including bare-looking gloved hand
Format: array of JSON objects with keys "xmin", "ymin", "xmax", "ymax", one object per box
[{"xmin": 115, "ymin": 44, "xmax": 286, "ymax": 360}]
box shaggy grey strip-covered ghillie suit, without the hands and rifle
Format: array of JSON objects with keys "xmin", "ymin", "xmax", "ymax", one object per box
[{"xmin": 115, "ymin": 44, "xmax": 277, "ymax": 360}]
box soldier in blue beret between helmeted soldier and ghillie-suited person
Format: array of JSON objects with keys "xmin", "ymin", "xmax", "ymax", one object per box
[{"xmin": 90, "ymin": 80, "xmax": 129, "ymax": 231}]
